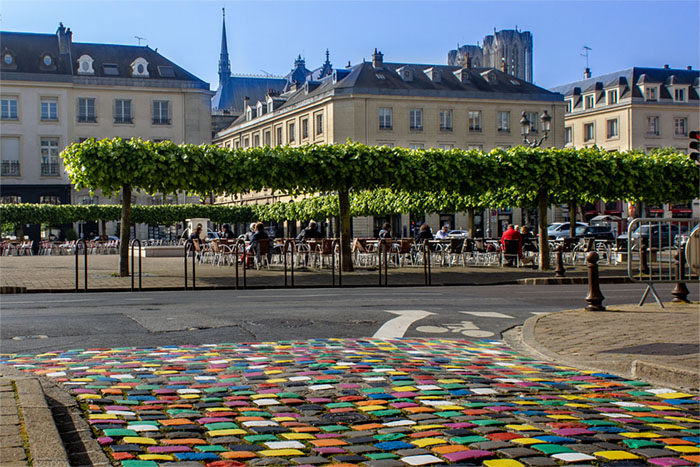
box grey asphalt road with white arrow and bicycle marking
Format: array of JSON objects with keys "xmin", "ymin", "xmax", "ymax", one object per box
[{"xmin": 0, "ymin": 284, "xmax": 698, "ymax": 353}]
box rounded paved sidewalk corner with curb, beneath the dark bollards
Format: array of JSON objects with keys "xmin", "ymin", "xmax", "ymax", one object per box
[{"xmin": 504, "ymin": 302, "xmax": 700, "ymax": 390}]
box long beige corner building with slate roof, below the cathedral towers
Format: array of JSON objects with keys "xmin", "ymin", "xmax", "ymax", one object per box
[{"xmin": 214, "ymin": 50, "xmax": 564, "ymax": 236}]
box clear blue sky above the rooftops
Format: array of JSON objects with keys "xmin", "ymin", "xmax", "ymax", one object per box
[{"xmin": 0, "ymin": 0, "xmax": 700, "ymax": 90}]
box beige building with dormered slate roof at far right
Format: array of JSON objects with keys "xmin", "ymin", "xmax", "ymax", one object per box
[{"xmin": 552, "ymin": 65, "xmax": 700, "ymax": 218}]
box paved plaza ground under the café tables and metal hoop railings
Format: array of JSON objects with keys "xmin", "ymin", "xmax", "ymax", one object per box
[{"xmin": 0, "ymin": 255, "xmax": 626, "ymax": 291}]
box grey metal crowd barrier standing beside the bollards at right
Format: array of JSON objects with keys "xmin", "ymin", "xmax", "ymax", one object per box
[{"xmin": 627, "ymin": 218, "xmax": 700, "ymax": 308}]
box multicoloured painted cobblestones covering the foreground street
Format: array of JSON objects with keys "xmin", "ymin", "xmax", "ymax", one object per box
[{"xmin": 0, "ymin": 339, "xmax": 700, "ymax": 467}]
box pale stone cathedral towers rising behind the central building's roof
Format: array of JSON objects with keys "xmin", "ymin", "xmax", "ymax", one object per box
[{"xmin": 447, "ymin": 26, "xmax": 533, "ymax": 83}]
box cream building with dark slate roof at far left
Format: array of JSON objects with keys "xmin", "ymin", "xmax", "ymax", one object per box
[{"xmin": 0, "ymin": 25, "xmax": 212, "ymax": 240}]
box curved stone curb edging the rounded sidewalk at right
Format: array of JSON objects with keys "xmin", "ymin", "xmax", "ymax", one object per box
[{"xmin": 503, "ymin": 310, "xmax": 700, "ymax": 389}]
